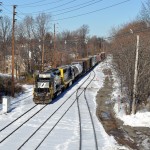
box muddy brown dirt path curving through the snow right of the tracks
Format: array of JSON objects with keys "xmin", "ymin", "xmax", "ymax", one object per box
[{"xmin": 96, "ymin": 69, "xmax": 150, "ymax": 150}]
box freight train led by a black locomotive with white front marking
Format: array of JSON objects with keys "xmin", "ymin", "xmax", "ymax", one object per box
[{"xmin": 33, "ymin": 52, "xmax": 106, "ymax": 104}]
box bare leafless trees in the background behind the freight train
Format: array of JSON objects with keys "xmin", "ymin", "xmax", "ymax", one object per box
[{"xmin": 0, "ymin": 13, "xmax": 102, "ymax": 73}]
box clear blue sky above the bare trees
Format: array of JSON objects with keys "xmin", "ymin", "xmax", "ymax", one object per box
[{"xmin": 0, "ymin": 0, "xmax": 146, "ymax": 37}]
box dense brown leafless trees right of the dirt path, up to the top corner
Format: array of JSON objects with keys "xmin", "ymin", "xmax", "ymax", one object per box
[{"xmin": 109, "ymin": 0, "xmax": 150, "ymax": 113}]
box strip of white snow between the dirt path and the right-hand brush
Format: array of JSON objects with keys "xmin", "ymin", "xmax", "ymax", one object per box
[{"xmin": 108, "ymin": 55, "xmax": 150, "ymax": 128}]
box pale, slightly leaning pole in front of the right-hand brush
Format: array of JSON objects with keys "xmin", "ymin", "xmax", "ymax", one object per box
[{"xmin": 132, "ymin": 35, "xmax": 139, "ymax": 114}]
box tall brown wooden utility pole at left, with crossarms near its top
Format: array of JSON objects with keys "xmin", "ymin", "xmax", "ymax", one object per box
[{"xmin": 11, "ymin": 5, "xmax": 17, "ymax": 97}]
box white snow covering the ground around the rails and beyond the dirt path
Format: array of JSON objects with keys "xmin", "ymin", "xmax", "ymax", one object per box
[{"xmin": 0, "ymin": 56, "xmax": 150, "ymax": 150}]
